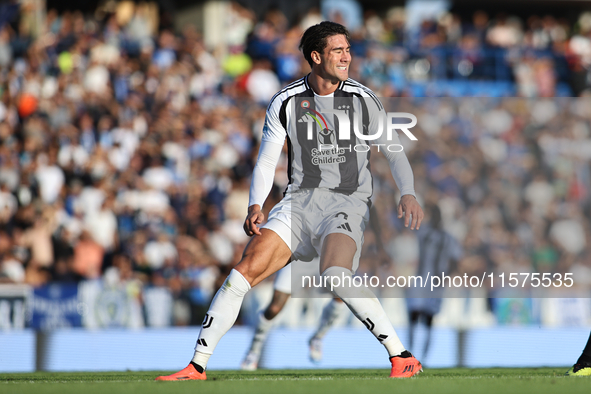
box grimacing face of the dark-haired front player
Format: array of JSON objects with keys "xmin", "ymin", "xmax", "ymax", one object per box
[{"xmin": 318, "ymin": 34, "xmax": 351, "ymax": 81}]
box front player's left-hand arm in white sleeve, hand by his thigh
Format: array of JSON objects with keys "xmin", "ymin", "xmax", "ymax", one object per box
[{"xmin": 244, "ymin": 100, "xmax": 287, "ymax": 237}]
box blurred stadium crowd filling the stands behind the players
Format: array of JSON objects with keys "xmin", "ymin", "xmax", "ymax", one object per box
[{"xmin": 0, "ymin": 0, "xmax": 591, "ymax": 325}]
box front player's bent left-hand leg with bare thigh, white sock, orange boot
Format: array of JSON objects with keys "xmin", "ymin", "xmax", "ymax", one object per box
[{"xmin": 156, "ymin": 229, "xmax": 291, "ymax": 381}]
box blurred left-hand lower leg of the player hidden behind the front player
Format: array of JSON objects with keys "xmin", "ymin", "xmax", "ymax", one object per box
[{"xmin": 240, "ymin": 290, "xmax": 289, "ymax": 371}]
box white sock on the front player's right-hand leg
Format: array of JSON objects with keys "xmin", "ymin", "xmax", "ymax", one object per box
[{"xmin": 322, "ymin": 267, "xmax": 405, "ymax": 357}]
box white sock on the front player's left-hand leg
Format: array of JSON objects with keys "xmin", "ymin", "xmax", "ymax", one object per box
[{"xmin": 193, "ymin": 269, "xmax": 250, "ymax": 369}]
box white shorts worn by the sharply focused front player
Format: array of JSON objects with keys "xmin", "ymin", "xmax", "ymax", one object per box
[{"xmin": 263, "ymin": 189, "xmax": 369, "ymax": 272}]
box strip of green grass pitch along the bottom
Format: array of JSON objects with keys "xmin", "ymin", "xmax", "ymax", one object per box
[{"xmin": 0, "ymin": 368, "xmax": 591, "ymax": 394}]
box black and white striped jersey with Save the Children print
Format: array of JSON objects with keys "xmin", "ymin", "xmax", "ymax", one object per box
[{"xmin": 263, "ymin": 76, "xmax": 390, "ymax": 201}]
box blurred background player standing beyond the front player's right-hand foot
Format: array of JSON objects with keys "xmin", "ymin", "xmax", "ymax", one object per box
[{"xmin": 406, "ymin": 204, "xmax": 463, "ymax": 359}]
